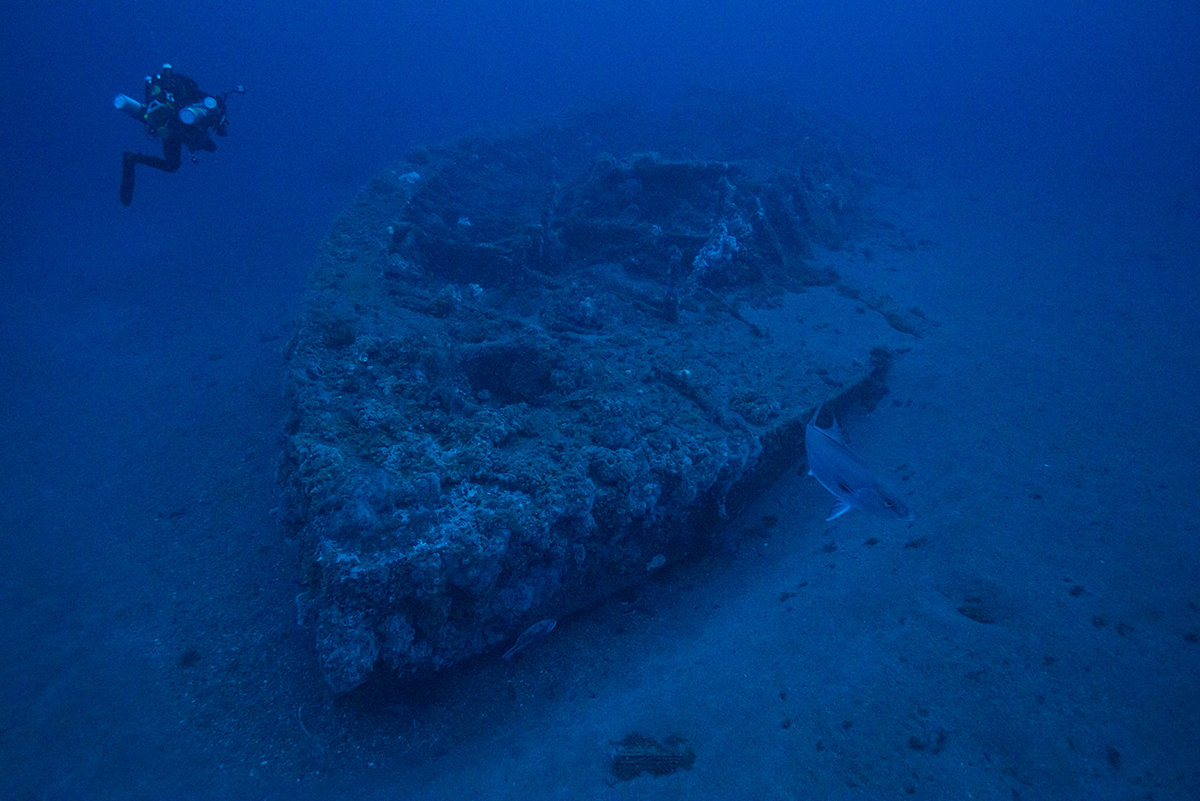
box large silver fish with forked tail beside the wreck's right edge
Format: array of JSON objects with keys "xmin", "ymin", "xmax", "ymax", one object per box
[{"xmin": 804, "ymin": 405, "xmax": 913, "ymax": 522}]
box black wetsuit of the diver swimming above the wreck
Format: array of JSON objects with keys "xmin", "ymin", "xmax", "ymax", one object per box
[{"xmin": 121, "ymin": 70, "xmax": 227, "ymax": 206}]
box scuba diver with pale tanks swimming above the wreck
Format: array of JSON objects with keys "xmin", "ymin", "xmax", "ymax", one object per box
[{"xmin": 113, "ymin": 64, "xmax": 246, "ymax": 206}]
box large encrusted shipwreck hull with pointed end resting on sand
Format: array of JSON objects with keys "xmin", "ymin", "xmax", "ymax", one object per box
[{"xmin": 281, "ymin": 94, "xmax": 916, "ymax": 692}]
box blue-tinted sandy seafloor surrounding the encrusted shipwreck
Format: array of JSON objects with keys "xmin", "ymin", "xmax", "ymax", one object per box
[{"xmin": 0, "ymin": 159, "xmax": 1200, "ymax": 800}]
